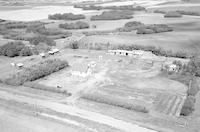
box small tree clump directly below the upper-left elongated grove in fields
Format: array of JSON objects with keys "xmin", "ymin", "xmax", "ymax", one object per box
[{"xmin": 59, "ymin": 21, "xmax": 90, "ymax": 30}]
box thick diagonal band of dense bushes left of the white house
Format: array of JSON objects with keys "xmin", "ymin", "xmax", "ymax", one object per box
[{"xmin": 5, "ymin": 59, "xmax": 68, "ymax": 86}]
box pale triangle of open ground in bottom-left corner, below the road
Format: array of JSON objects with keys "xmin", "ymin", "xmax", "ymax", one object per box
[{"xmin": 0, "ymin": 108, "xmax": 82, "ymax": 132}]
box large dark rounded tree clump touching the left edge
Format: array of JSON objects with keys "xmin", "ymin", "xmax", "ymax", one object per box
[{"xmin": 0, "ymin": 41, "xmax": 37, "ymax": 57}]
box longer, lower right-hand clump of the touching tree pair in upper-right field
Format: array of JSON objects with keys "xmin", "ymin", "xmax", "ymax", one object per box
[{"xmin": 137, "ymin": 24, "xmax": 173, "ymax": 34}]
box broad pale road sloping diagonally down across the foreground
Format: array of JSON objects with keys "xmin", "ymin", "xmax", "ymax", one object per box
[{"xmin": 0, "ymin": 86, "xmax": 156, "ymax": 132}]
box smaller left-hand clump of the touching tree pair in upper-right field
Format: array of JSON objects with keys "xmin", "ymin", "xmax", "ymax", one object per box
[{"xmin": 118, "ymin": 21, "xmax": 145, "ymax": 32}]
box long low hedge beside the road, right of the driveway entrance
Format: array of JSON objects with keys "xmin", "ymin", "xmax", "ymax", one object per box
[{"xmin": 81, "ymin": 94, "xmax": 149, "ymax": 113}]
